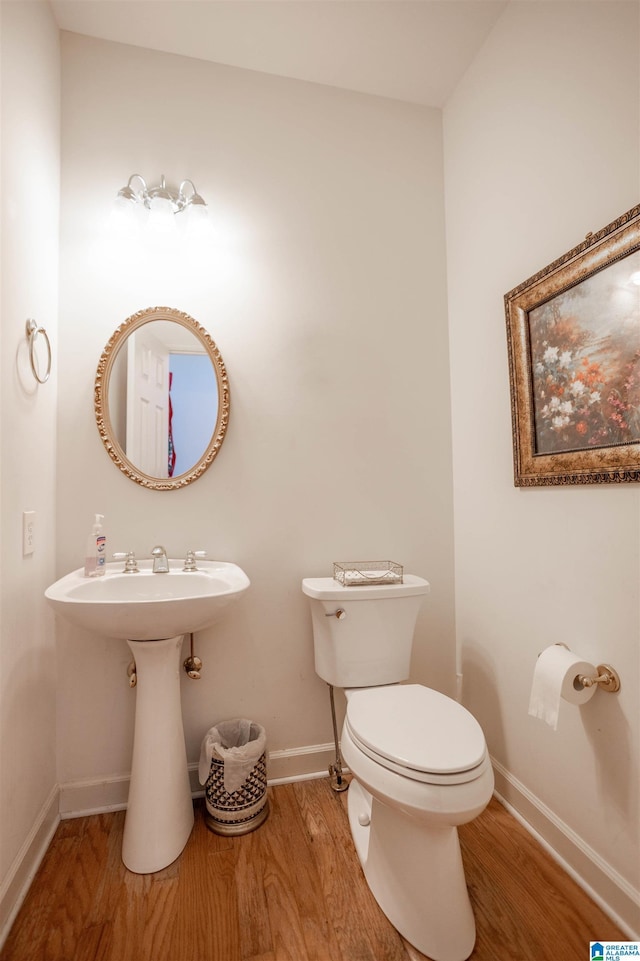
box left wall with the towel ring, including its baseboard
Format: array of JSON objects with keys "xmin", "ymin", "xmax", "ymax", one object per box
[{"xmin": 0, "ymin": 2, "xmax": 60, "ymax": 938}]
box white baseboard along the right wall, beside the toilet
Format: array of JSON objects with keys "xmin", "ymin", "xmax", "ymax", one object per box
[{"xmin": 492, "ymin": 758, "xmax": 640, "ymax": 941}]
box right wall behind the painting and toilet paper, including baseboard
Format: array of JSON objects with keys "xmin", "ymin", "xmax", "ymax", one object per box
[{"xmin": 444, "ymin": 2, "xmax": 640, "ymax": 936}]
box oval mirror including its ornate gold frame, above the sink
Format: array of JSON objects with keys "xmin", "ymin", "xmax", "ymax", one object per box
[{"xmin": 94, "ymin": 307, "xmax": 229, "ymax": 490}]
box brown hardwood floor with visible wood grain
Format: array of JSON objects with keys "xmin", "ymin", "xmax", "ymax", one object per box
[{"xmin": 0, "ymin": 779, "xmax": 625, "ymax": 961}]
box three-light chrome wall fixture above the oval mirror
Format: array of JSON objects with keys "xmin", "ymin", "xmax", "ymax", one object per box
[{"xmin": 115, "ymin": 174, "xmax": 208, "ymax": 230}]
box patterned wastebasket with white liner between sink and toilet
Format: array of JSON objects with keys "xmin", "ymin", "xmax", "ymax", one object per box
[{"xmin": 198, "ymin": 718, "xmax": 269, "ymax": 835}]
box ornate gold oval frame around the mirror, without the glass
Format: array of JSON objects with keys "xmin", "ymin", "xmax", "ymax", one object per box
[{"xmin": 94, "ymin": 307, "xmax": 230, "ymax": 491}]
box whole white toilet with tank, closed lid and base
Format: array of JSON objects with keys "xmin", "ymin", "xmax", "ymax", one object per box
[{"xmin": 302, "ymin": 574, "xmax": 493, "ymax": 961}]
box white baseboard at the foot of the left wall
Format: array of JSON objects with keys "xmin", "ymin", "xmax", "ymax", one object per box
[{"xmin": 0, "ymin": 784, "xmax": 60, "ymax": 950}]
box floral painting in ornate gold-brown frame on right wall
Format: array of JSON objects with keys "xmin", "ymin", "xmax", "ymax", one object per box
[{"xmin": 505, "ymin": 205, "xmax": 640, "ymax": 487}]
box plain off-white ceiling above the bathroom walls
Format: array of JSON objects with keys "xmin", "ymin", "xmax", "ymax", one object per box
[{"xmin": 51, "ymin": 0, "xmax": 508, "ymax": 107}]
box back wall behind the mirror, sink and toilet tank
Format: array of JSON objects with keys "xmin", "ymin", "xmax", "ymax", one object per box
[{"xmin": 57, "ymin": 34, "xmax": 455, "ymax": 797}]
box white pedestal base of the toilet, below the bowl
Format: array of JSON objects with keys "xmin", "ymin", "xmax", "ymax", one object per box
[{"xmin": 348, "ymin": 778, "xmax": 476, "ymax": 961}]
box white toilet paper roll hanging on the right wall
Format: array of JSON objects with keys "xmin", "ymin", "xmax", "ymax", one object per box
[{"xmin": 529, "ymin": 644, "xmax": 598, "ymax": 731}]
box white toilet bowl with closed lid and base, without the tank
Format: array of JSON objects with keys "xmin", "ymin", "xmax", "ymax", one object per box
[{"xmin": 341, "ymin": 684, "xmax": 494, "ymax": 961}]
